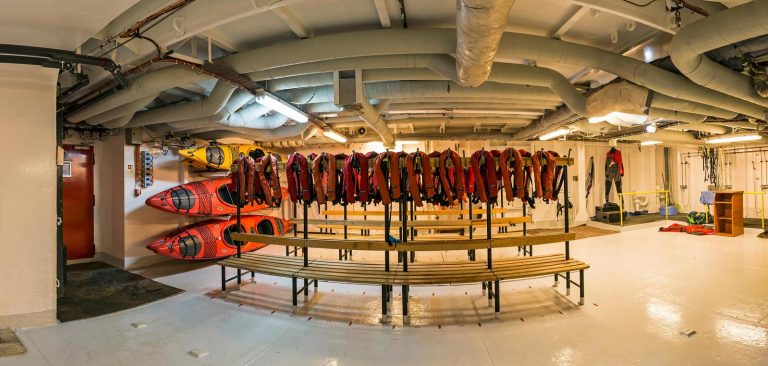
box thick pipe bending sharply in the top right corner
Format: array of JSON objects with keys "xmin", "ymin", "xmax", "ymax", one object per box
[{"xmin": 669, "ymin": 0, "xmax": 768, "ymax": 107}]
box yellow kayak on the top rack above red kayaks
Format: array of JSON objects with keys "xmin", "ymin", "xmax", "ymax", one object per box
[{"xmin": 179, "ymin": 144, "xmax": 271, "ymax": 170}]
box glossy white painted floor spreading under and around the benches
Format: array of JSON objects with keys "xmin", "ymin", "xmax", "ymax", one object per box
[{"xmin": 0, "ymin": 224, "xmax": 768, "ymax": 366}]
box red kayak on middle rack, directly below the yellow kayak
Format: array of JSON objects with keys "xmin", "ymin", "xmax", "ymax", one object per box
[{"xmin": 145, "ymin": 178, "xmax": 288, "ymax": 216}]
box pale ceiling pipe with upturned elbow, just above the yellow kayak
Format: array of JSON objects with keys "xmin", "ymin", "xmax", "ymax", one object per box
[{"xmin": 125, "ymin": 80, "xmax": 236, "ymax": 126}]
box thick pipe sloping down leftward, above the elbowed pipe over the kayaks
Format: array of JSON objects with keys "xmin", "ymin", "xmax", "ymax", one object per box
[{"xmin": 67, "ymin": 65, "xmax": 211, "ymax": 122}]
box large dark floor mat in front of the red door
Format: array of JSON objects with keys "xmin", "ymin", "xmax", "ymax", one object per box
[{"xmin": 57, "ymin": 262, "xmax": 183, "ymax": 322}]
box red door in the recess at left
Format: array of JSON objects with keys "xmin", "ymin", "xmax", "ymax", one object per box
[{"xmin": 63, "ymin": 145, "xmax": 95, "ymax": 259}]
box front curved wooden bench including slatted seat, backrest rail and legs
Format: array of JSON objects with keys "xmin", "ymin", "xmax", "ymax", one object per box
[{"xmin": 219, "ymin": 233, "xmax": 589, "ymax": 323}]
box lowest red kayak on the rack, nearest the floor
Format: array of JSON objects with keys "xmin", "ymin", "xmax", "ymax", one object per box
[{"xmin": 147, "ymin": 215, "xmax": 291, "ymax": 260}]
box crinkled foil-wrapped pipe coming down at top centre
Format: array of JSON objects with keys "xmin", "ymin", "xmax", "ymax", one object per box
[{"xmin": 455, "ymin": 0, "xmax": 514, "ymax": 87}]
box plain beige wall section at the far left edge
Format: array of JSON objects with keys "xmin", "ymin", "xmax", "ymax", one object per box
[{"xmin": 0, "ymin": 64, "xmax": 57, "ymax": 328}]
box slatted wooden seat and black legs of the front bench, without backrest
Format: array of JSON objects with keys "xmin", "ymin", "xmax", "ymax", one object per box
[{"xmin": 218, "ymin": 252, "xmax": 589, "ymax": 323}]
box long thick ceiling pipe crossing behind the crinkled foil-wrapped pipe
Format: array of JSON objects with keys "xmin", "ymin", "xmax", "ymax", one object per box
[{"xmin": 217, "ymin": 29, "xmax": 765, "ymax": 119}]
